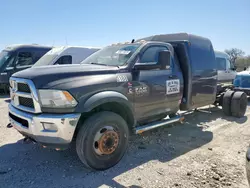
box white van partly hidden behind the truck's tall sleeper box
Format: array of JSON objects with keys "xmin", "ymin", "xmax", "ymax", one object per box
[{"xmin": 215, "ymin": 51, "xmax": 237, "ymax": 84}]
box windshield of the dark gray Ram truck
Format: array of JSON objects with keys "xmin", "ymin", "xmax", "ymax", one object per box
[{"xmin": 81, "ymin": 44, "xmax": 141, "ymax": 66}]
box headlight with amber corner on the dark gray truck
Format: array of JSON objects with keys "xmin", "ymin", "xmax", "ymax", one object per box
[{"xmin": 38, "ymin": 89, "xmax": 77, "ymax": 108}]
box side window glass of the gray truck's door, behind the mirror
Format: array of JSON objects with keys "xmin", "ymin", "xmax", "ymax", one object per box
[{"xmin": 140, "ymin": 46, "xmax": 167, "ymax": 63}]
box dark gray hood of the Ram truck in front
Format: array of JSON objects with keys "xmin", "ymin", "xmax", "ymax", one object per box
[{"xmin": 12, "ymin": 64, "xmax": 119, "ymax": 87}]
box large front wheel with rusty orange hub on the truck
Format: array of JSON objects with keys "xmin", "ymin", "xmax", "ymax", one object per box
[{"xmin": 76, "ymin": 111, "xmax": 129, "ymax": 170}]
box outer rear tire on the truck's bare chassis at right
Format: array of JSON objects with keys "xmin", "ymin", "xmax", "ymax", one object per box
[{"xmin": 231, "ymin": 91, "xmax": 247, "ymax": 118}]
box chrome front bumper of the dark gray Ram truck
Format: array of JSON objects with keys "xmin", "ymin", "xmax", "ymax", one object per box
[{"xmin": 9, "ymin": 104, "xmax": 81, "ymax": 145}]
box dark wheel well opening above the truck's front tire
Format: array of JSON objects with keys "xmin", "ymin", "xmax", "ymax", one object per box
[{"xmin": 74, "ymin": 102, "xmax": 134, "ymax": 140}]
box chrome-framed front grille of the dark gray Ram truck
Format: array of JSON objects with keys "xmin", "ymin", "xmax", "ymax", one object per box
[{"xmin": 10, "ymin": 77, "xmax": 41, "ymax": 113}]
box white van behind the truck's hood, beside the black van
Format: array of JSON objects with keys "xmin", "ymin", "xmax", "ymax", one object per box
[{"xmin": 33, "ymin": 46, "xmax": 100, "ymax": 67}]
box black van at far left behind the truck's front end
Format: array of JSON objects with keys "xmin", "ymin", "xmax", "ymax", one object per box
[{"xmin": 0, "ymin": 45, "xmax": 52, "ymax": 92}]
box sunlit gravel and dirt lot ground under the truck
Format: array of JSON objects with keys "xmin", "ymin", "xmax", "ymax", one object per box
[{"xmin": 0, "ymin": 97, "xmax": 250, "ymax": 188}]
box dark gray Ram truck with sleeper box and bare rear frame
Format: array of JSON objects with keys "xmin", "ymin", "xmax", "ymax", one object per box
[{"xmin": 9, "ymin": 33, "xmax": 247, "ymax": 170}]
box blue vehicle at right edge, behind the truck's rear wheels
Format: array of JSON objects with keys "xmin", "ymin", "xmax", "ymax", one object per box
[{"xmin": 234, "ymin": 69, "xmax": 250, "ymax": 95}]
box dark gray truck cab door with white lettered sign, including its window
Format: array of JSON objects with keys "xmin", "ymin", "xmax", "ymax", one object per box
[{"xmin": 132, "ymin": 45, "xmax": 181, "ymax": 120}]
